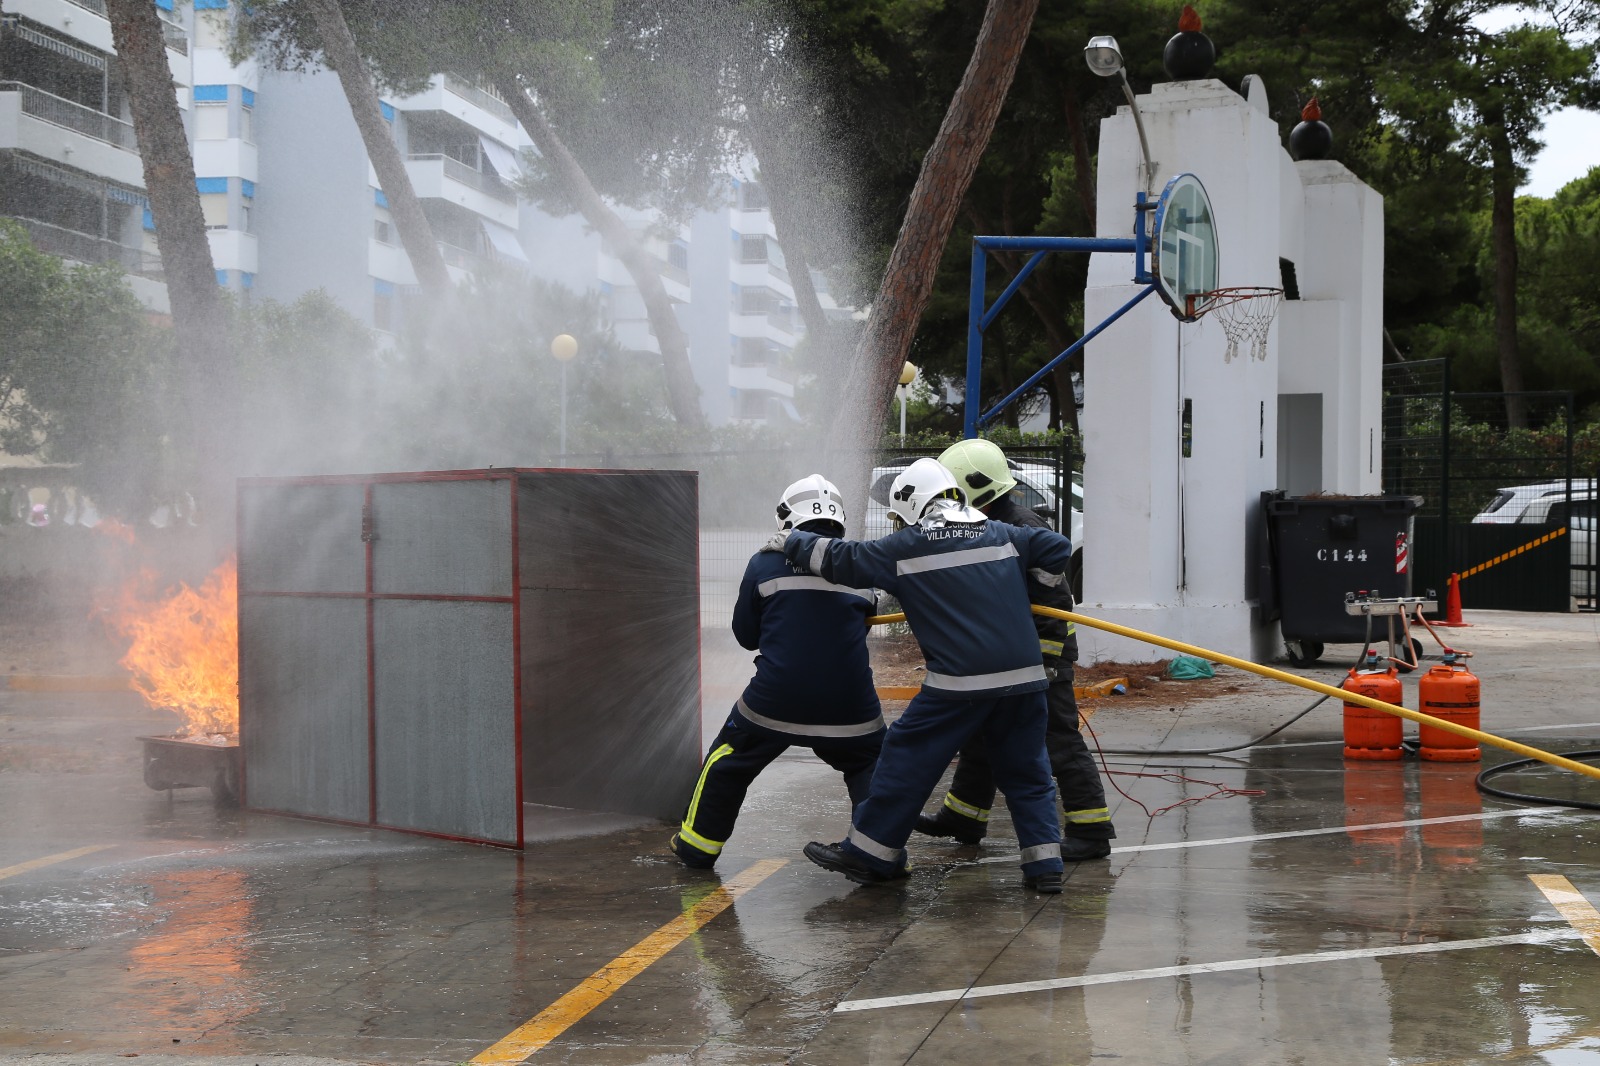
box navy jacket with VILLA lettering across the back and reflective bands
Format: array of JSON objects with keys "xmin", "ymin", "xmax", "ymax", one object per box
[{"xmin": 784, "ymin": 517, "xmax": 1072, "ymax": 699}]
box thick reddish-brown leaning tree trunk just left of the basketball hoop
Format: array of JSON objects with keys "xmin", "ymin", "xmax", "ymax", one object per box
[{"xmin": 829, "ymin": 0, "xmax": 1038, "ymax": 451}]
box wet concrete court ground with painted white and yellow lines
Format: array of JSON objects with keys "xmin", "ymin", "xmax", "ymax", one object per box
[{"xmin": 0, "ymin": 611, "xmax": 1600, "ymax": 1066}]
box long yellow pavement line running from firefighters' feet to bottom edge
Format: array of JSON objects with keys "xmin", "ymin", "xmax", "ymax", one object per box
[{"xmin": 469, "ymin": 860, "xmax": 789, "ymax": 1063}]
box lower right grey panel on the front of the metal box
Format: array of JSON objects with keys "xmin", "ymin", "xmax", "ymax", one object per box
[{"xmin": 373, "ymin": 598, "xmax": 518, "ymax": 844}]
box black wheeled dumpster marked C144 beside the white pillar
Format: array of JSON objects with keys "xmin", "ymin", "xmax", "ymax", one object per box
[{"xmin": 1261, "ymin": 491, "xmax": 1422, "ymax": 666}]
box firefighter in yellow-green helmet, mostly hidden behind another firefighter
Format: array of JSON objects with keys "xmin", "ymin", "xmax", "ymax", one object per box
[{"xmin": 917, "ymin": 439, "xmax": 1117, "ymax": 863}]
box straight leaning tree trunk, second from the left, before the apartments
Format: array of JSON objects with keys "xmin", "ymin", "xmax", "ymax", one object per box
[{"xmin": 306, "ymin": 0, "xmax": 451, "ymax": 298}]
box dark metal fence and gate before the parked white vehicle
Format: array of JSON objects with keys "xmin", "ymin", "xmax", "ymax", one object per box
[{"xmin": 1384, "ymin": 359, "xmax": 1600, "ymax": 611}]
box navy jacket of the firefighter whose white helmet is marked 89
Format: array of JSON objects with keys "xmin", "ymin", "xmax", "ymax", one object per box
[{"xmin": 733, "ymin": 552, "xmax": 882, "ymax": 736}]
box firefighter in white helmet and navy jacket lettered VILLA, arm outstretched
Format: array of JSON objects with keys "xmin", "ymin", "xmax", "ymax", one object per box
[{"xmin": 768, "ymin": 459, "xmax": 1072, "ymax": 892}]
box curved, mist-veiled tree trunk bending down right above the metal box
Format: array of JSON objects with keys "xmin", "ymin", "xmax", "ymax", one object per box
[{"xmin": 494, "ymin": 74, "xmax": 706, "ymax": 426}]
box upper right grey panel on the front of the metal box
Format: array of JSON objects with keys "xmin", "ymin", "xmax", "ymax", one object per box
[{"xmin": 371, "ymin": 479, "xmax": 512, "ymax": 597}]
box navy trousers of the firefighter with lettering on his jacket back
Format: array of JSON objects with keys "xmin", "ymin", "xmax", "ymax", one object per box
[{"xmin": 843, "ymin": 688, "xmax": 1064, "ymax": 877}]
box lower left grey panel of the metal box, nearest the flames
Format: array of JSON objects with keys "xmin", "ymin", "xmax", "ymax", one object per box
[{"xmin": 238, "ymin": 595, "xmax": 370, "ymax": 823}]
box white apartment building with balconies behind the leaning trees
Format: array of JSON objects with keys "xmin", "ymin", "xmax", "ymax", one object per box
[{"xmin": 0, "ymin": 0, "xmax": 843, "ymax": 424}]
